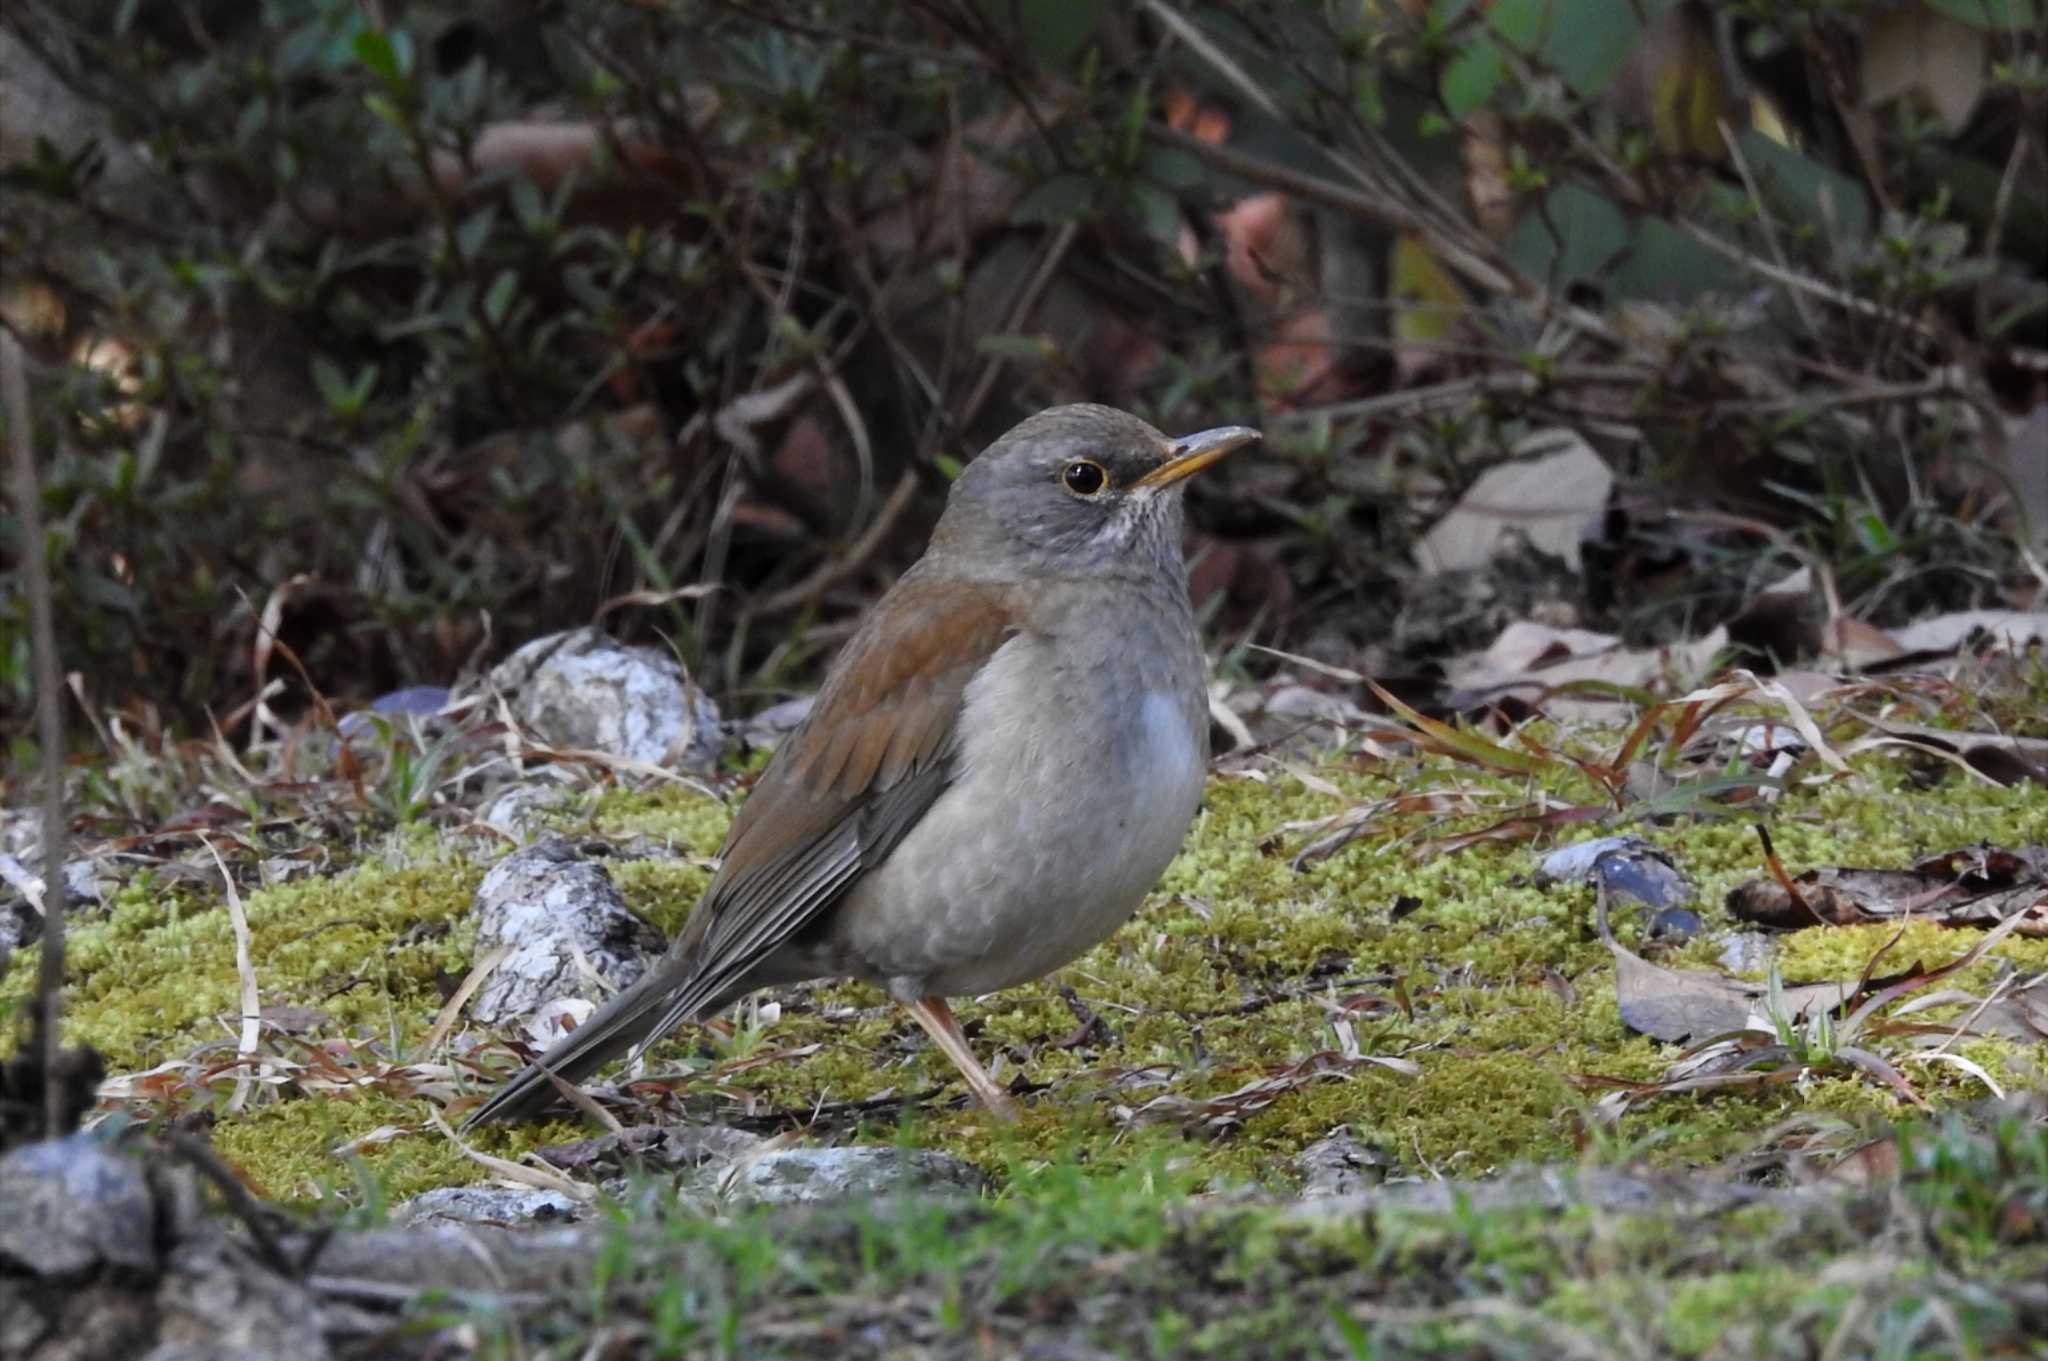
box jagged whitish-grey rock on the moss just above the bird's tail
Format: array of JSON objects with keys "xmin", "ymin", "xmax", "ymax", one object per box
[{"xmin": 471, "ymin": 837, "xmax": 666, "ymax": 1025}]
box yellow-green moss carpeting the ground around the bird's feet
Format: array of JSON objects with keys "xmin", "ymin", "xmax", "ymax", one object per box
[{"xmin": 0, "ymin": 728, "xmax": 2048, "ymax": 1197}]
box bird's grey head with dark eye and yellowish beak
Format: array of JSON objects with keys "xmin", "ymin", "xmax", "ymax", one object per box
[{"xmin": 932, "ymin": 405, "xmax": 1260, "ymax": 579}]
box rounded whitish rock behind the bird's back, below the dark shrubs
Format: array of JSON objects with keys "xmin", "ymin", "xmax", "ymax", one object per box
[{"xmin": 487, "ymin": 628, "xmax": 725, "ymax": 772}]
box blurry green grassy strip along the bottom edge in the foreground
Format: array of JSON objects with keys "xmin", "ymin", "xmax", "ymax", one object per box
[{"xmin": 436, "ymin": 1122, "xmax": 2048, "ymax": 1361}]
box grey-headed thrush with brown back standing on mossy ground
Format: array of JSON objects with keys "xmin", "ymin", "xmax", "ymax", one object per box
[{"xmin": 463, "ymin": 403, "xmax": 1260, "ymax": 1130}]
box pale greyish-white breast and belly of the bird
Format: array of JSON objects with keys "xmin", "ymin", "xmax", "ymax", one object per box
[{"xmin": 834, "ymin": 634, "xmax": 1206, "ymax": 997}]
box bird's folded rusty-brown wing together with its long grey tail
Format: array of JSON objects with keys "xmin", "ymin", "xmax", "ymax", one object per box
[{"xmin": 463, "ymin": 571, "xmax": 1018, "ymax": 1128}]
